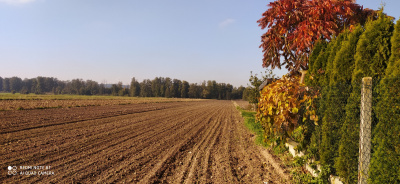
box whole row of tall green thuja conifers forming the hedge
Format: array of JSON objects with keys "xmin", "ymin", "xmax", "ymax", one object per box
[{"xmin": 306, "ymin": 13, "xmax": 400, "ymax": 183}]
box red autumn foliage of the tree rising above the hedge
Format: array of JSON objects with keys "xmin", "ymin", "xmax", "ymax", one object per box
[{"xmin": 257, "ymin": 0, "xmax": 373, "ymax": 72}]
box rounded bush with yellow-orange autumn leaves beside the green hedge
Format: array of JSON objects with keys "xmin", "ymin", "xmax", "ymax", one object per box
[{"xmin": 256, "ymin": 76, "xmax": 318, "ymax": 143}]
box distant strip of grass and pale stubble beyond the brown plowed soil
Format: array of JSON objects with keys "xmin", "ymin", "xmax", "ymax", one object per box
[{"xmin": 0, "ymin": 93, "xmax": 199, "ymax": 111}]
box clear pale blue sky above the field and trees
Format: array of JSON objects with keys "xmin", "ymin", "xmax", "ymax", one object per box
[{"xmin": 0, "ymin": 0, "xmax": 400, "ymax": 87}]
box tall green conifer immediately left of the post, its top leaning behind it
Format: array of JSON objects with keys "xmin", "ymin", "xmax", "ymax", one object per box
[{"xmin": 337, "ymin": 12, "xmax": 394, "ymax": 183}]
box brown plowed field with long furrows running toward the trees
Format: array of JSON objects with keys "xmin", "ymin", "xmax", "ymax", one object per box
[{"xmin": 0, "ymin": 100, "xmax": 289, "ymax": 184}]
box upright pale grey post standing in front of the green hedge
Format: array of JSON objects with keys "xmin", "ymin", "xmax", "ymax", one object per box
[{"xmin": 358, "ymin": 77, "xmax": 372, "ymax": 184}]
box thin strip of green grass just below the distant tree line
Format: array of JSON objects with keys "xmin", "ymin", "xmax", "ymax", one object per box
[{"xmin": 0, "ymin": 93, "xmax": 166, "ymax": 100}]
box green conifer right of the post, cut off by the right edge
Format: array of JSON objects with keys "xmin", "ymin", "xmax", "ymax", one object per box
[{"xmin": 369, "ymin": 20, "xmax": 400, "ymax": 183}]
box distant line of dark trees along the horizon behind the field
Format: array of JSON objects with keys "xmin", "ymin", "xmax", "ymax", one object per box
[{"xmin": 0, "ymin": 76, "xmax": 250, "ymax": 100}]
